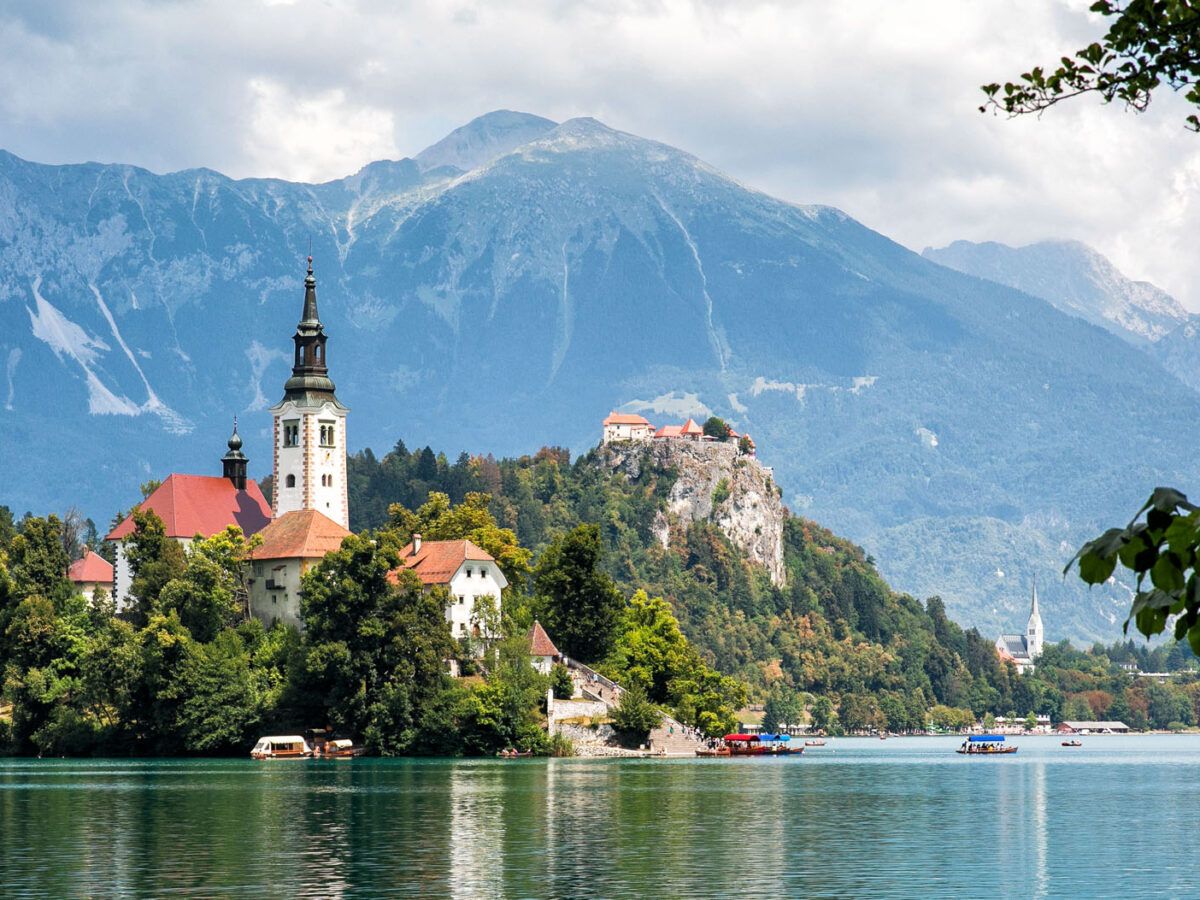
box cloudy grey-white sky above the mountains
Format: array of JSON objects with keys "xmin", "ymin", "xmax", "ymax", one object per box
[{"xmin": 7, "ymin": 0, "xmax": 1200, "ymax": 311}]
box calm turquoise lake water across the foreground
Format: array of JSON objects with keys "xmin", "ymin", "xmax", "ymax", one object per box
[{"xmin": 0, "ymin": 736, "xmax": 1200, "ymax": 898}]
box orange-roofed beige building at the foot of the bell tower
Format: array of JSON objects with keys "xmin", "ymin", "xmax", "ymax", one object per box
[{"xmin": 248, "ymin": 509, "xmax": 350, "ymax": 628}]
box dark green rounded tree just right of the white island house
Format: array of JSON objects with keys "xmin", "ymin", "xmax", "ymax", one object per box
[{"xmin": 533, "ymin": 524, "xmax": 625, "ymax": 662}]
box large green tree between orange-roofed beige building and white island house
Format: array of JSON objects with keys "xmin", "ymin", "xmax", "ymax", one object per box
[{"xmin": 301, "ymin": 535, "xmax": 454, "ymax": 754}]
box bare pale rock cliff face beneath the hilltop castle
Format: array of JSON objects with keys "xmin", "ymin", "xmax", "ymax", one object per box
[{"xmin": 599, "ymin": 440, "xmax": 787, "ymax": 584}]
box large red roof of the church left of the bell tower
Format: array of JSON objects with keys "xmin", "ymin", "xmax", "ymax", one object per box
[{"xmin": 107, "ymin": 474, "xmax": 271, "ymax": 541}]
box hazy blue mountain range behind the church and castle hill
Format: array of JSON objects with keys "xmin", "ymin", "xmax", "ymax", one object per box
[{"xmin": 0, "ymin": 112, "xmax": 1200, "ymax": 641}]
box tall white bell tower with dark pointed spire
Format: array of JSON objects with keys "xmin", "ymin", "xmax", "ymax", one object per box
[{"xmin": 270, "ymin": 257, "xmax": 350, "ymax": 528}]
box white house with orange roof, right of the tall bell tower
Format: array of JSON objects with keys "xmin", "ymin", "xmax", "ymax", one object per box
[{"xmin": 389, "ymin": 534, "xmax": 509, "ymax": 674}]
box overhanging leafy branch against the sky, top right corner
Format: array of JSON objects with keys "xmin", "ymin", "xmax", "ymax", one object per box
[{"xmin": 979, "ymin": 0, "xmax": 1200, "ymax": 131}]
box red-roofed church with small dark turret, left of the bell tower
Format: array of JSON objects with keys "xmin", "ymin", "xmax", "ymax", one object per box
[{"xmin": 107, "ymin": 448, "xmax": 271, "ymax": 610}]
